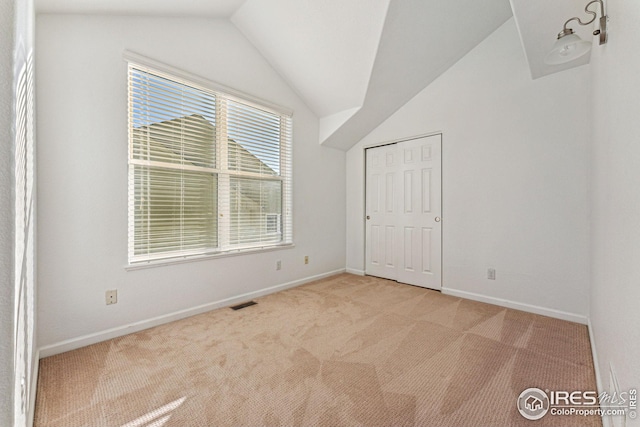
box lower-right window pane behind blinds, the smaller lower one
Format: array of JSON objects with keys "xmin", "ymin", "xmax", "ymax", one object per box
[{"xmin": 230, "ymin": 177, "xmax": 282, "ymax": 245}]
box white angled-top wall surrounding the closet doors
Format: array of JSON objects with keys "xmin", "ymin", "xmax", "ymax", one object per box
[{"xmin": 347, "ymin": 19, "xmax": 590, "ymax": 322}]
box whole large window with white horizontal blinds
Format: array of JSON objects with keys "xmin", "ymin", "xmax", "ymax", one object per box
[{"xmin": 129, "ymin": 62, "xmax": 292, "ymax": 264}]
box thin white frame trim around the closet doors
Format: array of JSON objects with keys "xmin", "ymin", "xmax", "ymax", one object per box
[{"xmin": 361, "ymin": 131, "xmax": 446, "ymax": 291}]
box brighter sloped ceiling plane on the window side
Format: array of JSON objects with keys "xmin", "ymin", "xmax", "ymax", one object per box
[{"xmin": 231, "ymin": 0, "xmax": 389, "ymax": 117}]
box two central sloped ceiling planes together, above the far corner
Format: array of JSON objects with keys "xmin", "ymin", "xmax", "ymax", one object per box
[{"xmin": 231, "ymin": 0, "xmax": 511, "ymax": 149}]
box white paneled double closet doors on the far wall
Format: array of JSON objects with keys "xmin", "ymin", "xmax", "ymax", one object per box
[{"xmin": 365, "ymin": 135, "xmax": 442, "ymax": 289}]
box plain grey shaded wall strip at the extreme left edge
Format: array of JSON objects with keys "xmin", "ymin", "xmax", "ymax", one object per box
[{"xmin": 0, "ymin": 0, "xmax": 15, "ymax": 426}]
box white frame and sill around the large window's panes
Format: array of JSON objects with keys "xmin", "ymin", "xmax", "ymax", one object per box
[{"xmin": 123, "ymin": 51, "xmax": 294, "ymax": 269}]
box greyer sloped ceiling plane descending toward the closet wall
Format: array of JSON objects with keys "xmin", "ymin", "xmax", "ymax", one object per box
[{"xmin": 320, "ymin": 0, "xmax": 511, "ymax": 149}]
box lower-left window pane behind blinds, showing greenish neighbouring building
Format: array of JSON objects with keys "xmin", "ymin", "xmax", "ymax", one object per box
[{"xmin": 134, "ymin": 165, "xmax": 218, "ymax": 256}]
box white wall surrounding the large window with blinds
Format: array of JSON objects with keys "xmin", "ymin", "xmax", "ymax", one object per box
[{"xmin": 37, "ymin": 15, "xmax": 345, "ymax": 354}]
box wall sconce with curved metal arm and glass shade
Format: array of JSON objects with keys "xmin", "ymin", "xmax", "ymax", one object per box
[{"xmin": 544, "ymin": 0, "xmax": 609, "ymax": 65}]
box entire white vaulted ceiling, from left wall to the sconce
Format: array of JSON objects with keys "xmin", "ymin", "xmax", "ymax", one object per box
[{"xmin": 36, "ymin": 0, "xmax": 592, "ymax": 150}]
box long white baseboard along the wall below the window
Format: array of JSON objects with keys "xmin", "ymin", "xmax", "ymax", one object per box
[{"xmin": 39, "ymin": 268, "xmax": 345, "ymax": 358}]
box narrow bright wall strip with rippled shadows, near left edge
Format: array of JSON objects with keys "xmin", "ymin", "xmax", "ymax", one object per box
[{"xmin": 13, "ymin": 0, "xmax": 38, "ymax": 426}]
